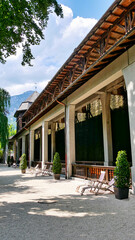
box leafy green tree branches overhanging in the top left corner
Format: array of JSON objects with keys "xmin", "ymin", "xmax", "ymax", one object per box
[{"xmin": 0, "ymin": 0, "xmax": 63, "ymax": 66}]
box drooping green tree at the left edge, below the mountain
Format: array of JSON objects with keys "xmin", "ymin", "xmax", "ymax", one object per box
[{"xmin": 0, "ymin": 88, "xmax": 10, "ymax": 149}]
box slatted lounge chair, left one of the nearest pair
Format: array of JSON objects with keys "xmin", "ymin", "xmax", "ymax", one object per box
[{"xmin": 81, "ymin": 171, "xmax": 105, "ymax": 196}]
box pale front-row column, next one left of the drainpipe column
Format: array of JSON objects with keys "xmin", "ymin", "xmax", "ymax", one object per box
[{"xmin": 42, "ymin": 121, "xmax": 48, "ymax": 168}]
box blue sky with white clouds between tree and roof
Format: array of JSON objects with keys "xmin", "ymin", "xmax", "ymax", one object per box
[{"xmin": 0, "ymin": 0, "xmax": 114, "ymax": 96}]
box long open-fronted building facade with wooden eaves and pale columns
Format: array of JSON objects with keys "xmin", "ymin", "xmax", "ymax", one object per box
[{"xmin": 13, "ymin": 0, "xmax": 135, "ymax": 192}]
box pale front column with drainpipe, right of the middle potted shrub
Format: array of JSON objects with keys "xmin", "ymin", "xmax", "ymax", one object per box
[{"xmin": 66, "ymin": 105, "xmax": 75, "ymax": 178}]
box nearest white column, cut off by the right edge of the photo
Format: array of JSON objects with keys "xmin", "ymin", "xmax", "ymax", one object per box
[{"xmin": 123, "ymin": 62, "xmax": 135, "ymax": 194}]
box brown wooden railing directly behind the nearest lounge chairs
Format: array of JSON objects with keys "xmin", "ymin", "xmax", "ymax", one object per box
[{"xmin": 72, "ymin": 164, "xmax": 115, "ymax": 181}]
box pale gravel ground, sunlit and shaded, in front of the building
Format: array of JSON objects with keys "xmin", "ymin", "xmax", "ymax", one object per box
[{"xmin": 0, "ymin": 165, "xmax": 135, "ymax": 240}]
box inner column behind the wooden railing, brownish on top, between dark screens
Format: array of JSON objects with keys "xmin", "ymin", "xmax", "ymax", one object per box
[{"xmin": 101, "ymin": 93, "xmax": 113, "ymax": 166}]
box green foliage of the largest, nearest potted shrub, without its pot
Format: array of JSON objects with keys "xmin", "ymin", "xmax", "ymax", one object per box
[{"xmin": 114, "ymin": 151, "xmax": 130, "ymax": 188}]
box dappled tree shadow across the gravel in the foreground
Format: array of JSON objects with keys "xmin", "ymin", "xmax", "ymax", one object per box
[{"xmin": 1, "ymin": 195, "xmax": 135, "ymax": 240}]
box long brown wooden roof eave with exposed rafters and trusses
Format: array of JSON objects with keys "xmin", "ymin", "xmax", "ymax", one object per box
[{"xmin": 12, "ymin": 0, "xmax": 135, "ymax": 139}]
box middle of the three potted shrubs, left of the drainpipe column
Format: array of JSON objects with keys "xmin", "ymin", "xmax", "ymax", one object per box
[{"xmin": 52, "ymin": 152, "xmax": 62, "ymax": 180}]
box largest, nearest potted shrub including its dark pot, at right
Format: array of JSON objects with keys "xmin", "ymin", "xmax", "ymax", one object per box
[{"xmin": 114, "ymin": 151, "xmax": 130, "ymax": 199}]
